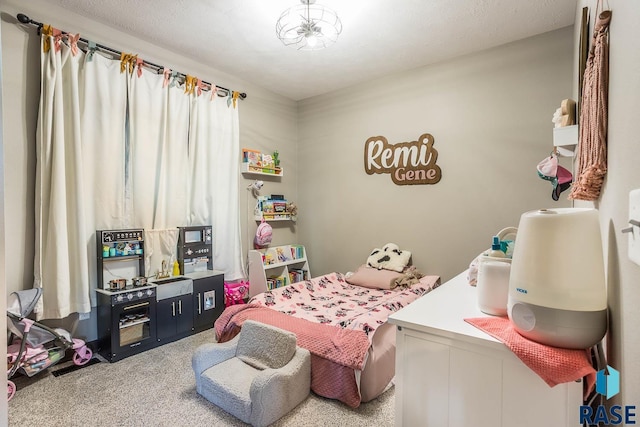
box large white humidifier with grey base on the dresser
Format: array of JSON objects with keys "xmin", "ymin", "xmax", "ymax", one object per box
[{"xmin": 507, "ymin": 208, "xmax": 607, "ymax": 349}]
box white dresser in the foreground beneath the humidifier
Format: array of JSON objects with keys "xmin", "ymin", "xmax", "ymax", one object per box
[{"xmin": 389, "ymin": 272, "xmax": 582, "ymax": 427}]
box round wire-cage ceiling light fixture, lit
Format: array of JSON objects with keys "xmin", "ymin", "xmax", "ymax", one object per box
[{"xmin": 276, "ymin": 0, "xmax": 342, "ymax": 50}]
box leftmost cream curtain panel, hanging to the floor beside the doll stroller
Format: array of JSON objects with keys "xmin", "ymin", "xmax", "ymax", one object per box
[{"xmin": 34, "ymin": 34, "xmax": 91, "ymax": 319}]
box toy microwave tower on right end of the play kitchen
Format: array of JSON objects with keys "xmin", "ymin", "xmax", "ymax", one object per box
[{"xmin": 178, "ymin": 225, "xmax": 213, "ymax": 274}]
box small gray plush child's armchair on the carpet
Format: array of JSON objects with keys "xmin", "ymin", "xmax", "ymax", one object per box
[{"xmin": 191, "ymin": 320, "xmax": 311, "ymax": 426}]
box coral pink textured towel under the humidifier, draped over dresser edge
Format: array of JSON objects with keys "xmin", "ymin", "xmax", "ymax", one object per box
[{"xmin": 464, "ymin": 317, "xmax": 596, "ymax": 396}]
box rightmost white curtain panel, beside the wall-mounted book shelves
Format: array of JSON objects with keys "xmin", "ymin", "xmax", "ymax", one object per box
[{"xmin": 188, "ymin": 95, "xmax": 245, "ymax": 280}]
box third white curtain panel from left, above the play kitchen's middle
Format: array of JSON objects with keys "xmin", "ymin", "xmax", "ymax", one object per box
[{"xmin": 129, "ymin": 69, "xmax": 189, "ymax": 229}]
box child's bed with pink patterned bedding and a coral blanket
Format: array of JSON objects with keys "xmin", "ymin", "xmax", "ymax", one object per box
[{"xmin": 215, "ymin": 266, "xmax": 440, "ymax": 408}]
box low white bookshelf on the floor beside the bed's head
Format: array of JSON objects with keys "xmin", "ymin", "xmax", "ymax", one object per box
[{"xmin": 249, "ymin": 245, "xmax": 311, "ymax": 297}]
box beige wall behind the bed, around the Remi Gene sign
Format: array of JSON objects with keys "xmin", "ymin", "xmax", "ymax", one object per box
[{"xmin": 298, "ymin": 27, "xmax": 573, "ymax": 280}]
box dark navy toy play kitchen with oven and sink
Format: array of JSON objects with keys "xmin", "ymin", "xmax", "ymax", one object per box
[{"xmin": 96, "ymin": 226, "xmax": 224, "ymax": 362}]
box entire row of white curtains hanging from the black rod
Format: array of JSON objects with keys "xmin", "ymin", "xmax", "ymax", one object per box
[{"xmin": 34, "ymin": 30, "xmax": 244, "ymax": 318}]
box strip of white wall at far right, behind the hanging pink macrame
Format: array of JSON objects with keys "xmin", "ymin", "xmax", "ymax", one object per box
[{"xmin": 574, "ymin": 0, "xmax": 640, "ymax": 407}]
